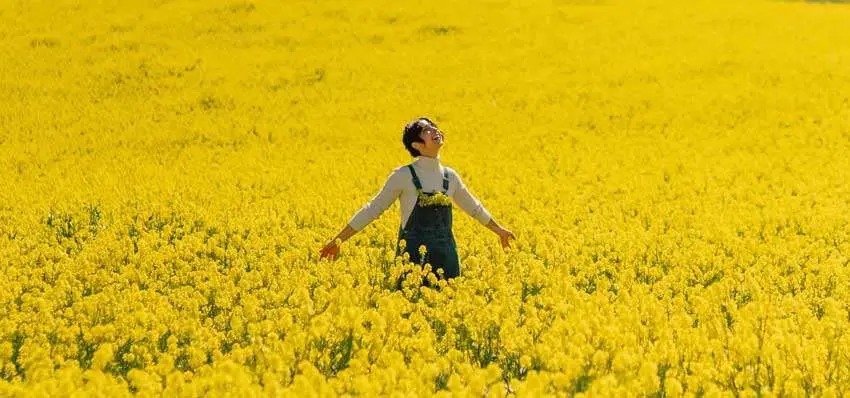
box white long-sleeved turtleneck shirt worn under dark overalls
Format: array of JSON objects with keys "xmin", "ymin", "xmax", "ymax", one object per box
[{"xmin": 348, "ymin": 156, "xmax": 490, "ymax": 231}]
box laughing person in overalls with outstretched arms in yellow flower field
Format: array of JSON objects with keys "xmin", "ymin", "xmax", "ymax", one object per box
[{"xmin": 321, "ymin": 117, "xmax": 515, "ymax": 284}]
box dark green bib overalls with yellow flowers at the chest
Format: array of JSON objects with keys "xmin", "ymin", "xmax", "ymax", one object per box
[{"xmin": 396, "ymin": 165, "xmax": 460, "ymax": 287}]
